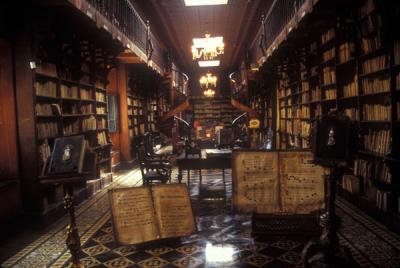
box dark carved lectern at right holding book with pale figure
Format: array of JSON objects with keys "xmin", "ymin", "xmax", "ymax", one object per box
[{"xmin": 303, "ymin": 112, "xmax": 357, "ymax": 267}]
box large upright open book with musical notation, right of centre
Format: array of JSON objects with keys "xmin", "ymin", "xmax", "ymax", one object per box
[{"xmin": 232, "ymin": 151, "xmax": 325, "ymax": 214}]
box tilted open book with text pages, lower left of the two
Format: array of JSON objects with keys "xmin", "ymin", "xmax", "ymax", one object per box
[{"xmin": 109, "ymin": 184, "xmax": 196, "ymax": 245}]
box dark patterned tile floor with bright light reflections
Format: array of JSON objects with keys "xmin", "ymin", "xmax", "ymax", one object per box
[{"xmin": 2, "ymin": 170, "xmax": 400, "ymax": 267}]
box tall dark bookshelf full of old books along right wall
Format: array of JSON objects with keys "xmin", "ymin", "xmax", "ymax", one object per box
[{"xmin": 252, "ymin": 0, "xmax": 400, "ymax": 231}]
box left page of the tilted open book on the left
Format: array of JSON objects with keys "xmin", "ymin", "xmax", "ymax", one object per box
[{"xmin": 109, "ymin": 187, "xmax": 159, "ymax": 245}]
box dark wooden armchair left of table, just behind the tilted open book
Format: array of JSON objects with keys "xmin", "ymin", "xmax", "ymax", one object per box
[{"xmin": 139, "ymin": 146, "xmax": 172, "ymax": 184}]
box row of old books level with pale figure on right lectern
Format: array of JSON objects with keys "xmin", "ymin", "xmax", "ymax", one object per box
[{"xmin": 364, "ymin": 129, "xmax": 390, "ymax": 155}]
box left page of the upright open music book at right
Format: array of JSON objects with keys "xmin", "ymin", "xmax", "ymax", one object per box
[{"xmin": 232, "ymin": 152, "xmax": 279, "ymax": 213}]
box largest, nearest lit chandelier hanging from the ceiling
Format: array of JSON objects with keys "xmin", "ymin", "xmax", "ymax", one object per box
[{"xmin": 192, "ymin": 34, "xmax": 224, "ymax": 61}]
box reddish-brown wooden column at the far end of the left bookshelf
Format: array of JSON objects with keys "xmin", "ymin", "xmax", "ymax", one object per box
[{"xmin": 117, "ymin": 63, "xmax": 132, "ymax": 166}]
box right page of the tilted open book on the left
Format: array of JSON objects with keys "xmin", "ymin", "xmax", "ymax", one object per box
[{"xmin": 152, "ymin": 184, "xmax": 196, "ymax": 238}]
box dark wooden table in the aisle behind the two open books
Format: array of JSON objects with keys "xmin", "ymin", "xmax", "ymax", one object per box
[{"xmin": 176, "ymin": 149, "xmax": 232, "ymax": 186}]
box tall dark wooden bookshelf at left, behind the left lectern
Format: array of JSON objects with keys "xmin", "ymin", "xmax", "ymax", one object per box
[{"xmin": 16, "ymin": 27, "xmax": 116, "ymax": 214}]
